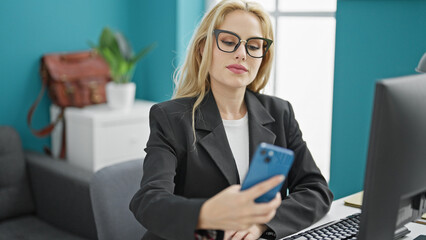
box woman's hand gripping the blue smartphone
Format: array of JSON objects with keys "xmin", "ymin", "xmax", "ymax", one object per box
[{"xmin": 197, "ymin": 175, "xmax": 284, "ymax": 231}]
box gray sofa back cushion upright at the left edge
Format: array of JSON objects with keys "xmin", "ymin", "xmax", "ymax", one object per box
[{"xmin": 0, "ymin": 126, "xmax": 34, "ymax": 221}]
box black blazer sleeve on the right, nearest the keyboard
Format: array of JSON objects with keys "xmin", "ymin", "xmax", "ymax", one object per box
[{"xmin": 267, "ymin": 103, "xmax": 333, "ymax": 239}]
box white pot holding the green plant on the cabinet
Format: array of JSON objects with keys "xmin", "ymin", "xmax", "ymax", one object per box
[{"xmin": 106, "ymin": 82, "xmax": 136, "ymax": 110}]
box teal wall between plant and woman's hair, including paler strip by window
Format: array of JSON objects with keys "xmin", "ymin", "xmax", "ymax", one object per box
[{"xmin": 130, "ymin": 0, "xmax": 204, "ymax": 101}]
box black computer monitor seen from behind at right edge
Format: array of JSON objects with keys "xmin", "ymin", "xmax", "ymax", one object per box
[{"xmin": 357, "ymin": 74, "xmax": 426, "ymax": 240}]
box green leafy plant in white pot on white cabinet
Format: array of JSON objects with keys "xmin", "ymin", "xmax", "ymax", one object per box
[{"xmin": 89, "ymin": 27, "xmax": 156, "ymax": 109}]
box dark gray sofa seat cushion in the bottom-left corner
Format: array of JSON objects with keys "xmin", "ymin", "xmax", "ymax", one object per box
[{"xmin": 0, "ymin": 215, "xmax": 87, "ymax": 240}]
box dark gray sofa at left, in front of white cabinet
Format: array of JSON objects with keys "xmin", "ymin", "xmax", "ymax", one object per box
[{"xmin": 0, "ymin": 126, "xmax": 97, "ymax": 240}]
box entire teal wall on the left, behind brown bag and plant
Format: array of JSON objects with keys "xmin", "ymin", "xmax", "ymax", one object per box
[{"xmin": 0, "ymin": 0, "xmax": 204, "ymax": 151}]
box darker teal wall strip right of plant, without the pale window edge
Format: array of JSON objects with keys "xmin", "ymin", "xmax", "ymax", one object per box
[{"xmin": 130, "ymin": 0, "xmax": 177, "ymax": 101}]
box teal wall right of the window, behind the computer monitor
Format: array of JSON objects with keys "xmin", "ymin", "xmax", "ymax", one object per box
[{"xmin": 330, "ymin": 0, "xmax": 426, "ymax": 198}]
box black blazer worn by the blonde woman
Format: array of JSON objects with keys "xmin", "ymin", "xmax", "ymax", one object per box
[{"xmin": 130, "ymin": 90, "xmax": 333, "ymax": 240}]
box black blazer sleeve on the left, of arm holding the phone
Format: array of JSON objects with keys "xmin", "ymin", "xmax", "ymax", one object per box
[{"xmin": 130, "ymin": 105, "xmax": 205, "ymax": 240}]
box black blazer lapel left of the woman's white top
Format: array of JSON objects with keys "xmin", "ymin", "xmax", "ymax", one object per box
[{"xmin": 195, "ymin": 91, "xmax": 239, "ymax": 185}]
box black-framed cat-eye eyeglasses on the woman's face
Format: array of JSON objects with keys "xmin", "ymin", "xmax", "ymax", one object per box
[{"xmin": 213, "ymin": 29, "xmax": 272, "ymax": 58}]
